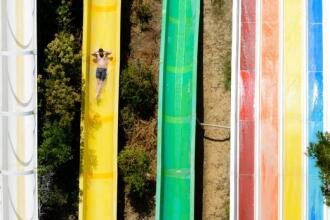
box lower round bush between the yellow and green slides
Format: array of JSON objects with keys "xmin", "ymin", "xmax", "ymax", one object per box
[{"xmin": 118, "ymin": 146, "xmax": 151, "ymax": 197}]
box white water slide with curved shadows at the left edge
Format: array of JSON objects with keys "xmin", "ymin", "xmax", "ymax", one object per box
[{"xmin": 0, "ymin": 0, "xmax": 38, "ymax": 220}]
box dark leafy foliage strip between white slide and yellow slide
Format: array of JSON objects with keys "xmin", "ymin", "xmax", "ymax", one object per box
[{"xmin": 38, "ymin": 0, "xmax": 81, "ymax": 219}]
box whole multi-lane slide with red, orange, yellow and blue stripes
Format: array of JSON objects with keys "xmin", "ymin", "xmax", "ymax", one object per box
[{"xmin": 230, "ymin": 0, "xmax": 330, "ymax": 220}]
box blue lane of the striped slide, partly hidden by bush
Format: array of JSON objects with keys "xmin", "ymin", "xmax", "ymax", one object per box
[{"xmin": 307, "ymin": 0, "xmax": 329, "ymax": 220}]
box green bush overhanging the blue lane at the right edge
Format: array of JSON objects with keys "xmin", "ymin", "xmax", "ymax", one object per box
[{"xmin": 307, "ymin": 132, "xmax": 330, "ymax": 206}]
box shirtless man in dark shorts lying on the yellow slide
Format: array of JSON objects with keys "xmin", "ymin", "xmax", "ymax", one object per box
[{"xmin": 92, "ymin": 48, "xmax": 112, "ymax": 100}]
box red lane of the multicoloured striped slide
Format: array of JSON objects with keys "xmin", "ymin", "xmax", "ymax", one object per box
[{"xmin": 238, "ymin": 0, "xmax": 256, "ymax": 220}]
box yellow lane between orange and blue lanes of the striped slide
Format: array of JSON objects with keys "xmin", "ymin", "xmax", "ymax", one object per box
[{"xmin": 283, "ymin": 0, "xmax": 306, "ymax": 219}]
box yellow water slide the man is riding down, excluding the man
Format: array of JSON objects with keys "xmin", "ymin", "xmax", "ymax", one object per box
[{"xmin": 79, "ymin": 0, "xmax": 121, "ymax": 220}]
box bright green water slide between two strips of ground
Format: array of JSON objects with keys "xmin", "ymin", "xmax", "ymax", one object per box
[{"xmin": 156, "ymin": 0, "xmax": 200, "ymax": 220}]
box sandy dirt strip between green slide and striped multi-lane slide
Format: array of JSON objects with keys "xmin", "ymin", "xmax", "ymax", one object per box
[{"xmin": 202, "ymin": 0, "xmax": 232, "ymax": 220}]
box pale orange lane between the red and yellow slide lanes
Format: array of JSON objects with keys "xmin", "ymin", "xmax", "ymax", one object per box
[{"xmin": 258, "ymin": 0, "xmax": 281, "ymax": 220}]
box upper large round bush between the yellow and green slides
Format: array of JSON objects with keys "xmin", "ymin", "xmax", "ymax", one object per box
[{"xmin": 120, "ymin": 63, "xmax": 157, "ymax": 119}]
